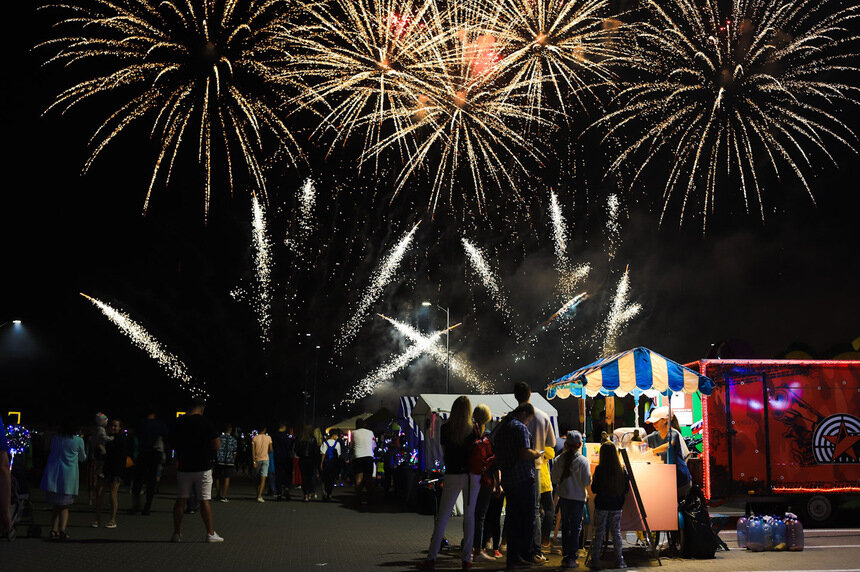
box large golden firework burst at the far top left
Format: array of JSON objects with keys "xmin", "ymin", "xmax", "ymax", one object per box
[{"xmin": 38, "ymin": 0, "xmax": 299, "ymax": 222}]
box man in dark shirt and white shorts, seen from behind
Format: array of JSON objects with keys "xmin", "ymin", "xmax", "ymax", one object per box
[{"xmin": 170, "ymin": 397, "xmax": 224, "ymax": 542}]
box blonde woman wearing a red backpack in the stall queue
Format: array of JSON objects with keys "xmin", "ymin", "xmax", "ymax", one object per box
[{"xmin": 469, "ymin": 403, "xmax": 499, "ymax": 560}]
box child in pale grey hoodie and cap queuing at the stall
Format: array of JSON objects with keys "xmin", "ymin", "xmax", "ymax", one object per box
[{"xmin": 552, "ymin": 431, "xmax": 591, "ymax": 568}]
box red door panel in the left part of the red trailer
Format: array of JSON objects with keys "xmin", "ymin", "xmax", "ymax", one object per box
[{"xmin": 726, "ymin": 374, "xmax": 768, "ymax": 492}]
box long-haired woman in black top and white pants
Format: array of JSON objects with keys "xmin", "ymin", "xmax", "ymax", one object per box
[{"xmin": 421, "ymin": 395, "xmax": 481, "ymax": 570}]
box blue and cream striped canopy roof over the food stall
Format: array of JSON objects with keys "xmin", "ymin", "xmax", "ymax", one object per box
[{"xmin": 546, "ymin": 348, "xmax": 714, "ymax": 399}]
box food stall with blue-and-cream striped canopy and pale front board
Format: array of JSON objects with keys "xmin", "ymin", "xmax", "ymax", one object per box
[{"xmin": 546, "ymin": 347, "xmax": 713, "ymax": 530}]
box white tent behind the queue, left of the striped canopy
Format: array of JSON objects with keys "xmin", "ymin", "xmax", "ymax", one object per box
[{"xmin": 411, "ymin": 393, "xmax": 558, "ymax": 470}]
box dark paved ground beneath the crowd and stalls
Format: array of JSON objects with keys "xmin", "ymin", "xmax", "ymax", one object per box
[{"xmin": 0, "ymin": 470, "xmax": 860, "ymax": 572}]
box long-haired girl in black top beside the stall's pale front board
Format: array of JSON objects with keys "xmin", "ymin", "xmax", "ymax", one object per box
[{"xmin": 589, "ymin": 442, "xmax": 629, "ymax": 570}]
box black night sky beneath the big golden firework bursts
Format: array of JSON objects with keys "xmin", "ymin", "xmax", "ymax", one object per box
[{"xmin": 0, "ymin": 2, "xmax": 860, "ymax": 423}]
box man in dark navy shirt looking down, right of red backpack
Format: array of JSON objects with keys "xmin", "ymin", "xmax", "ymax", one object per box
[{"xmin": 494, "ymin": 403, "xmax": 544, "ymax": 568}]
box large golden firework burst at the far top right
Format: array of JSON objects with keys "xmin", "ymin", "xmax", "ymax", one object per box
[{"xmin": 595, "ymin": 0, "xmax": 860, "ymax": 231}]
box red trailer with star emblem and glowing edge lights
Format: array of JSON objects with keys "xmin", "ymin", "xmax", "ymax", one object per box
[{"xmin": 691, "ymin": 359, "xmax": 860, "ymax": 524}]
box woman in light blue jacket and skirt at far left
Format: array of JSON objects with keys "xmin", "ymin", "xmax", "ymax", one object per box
[{"xmin": 40, "ymin": 419, "xmax": 87, "ymax": 540}]
